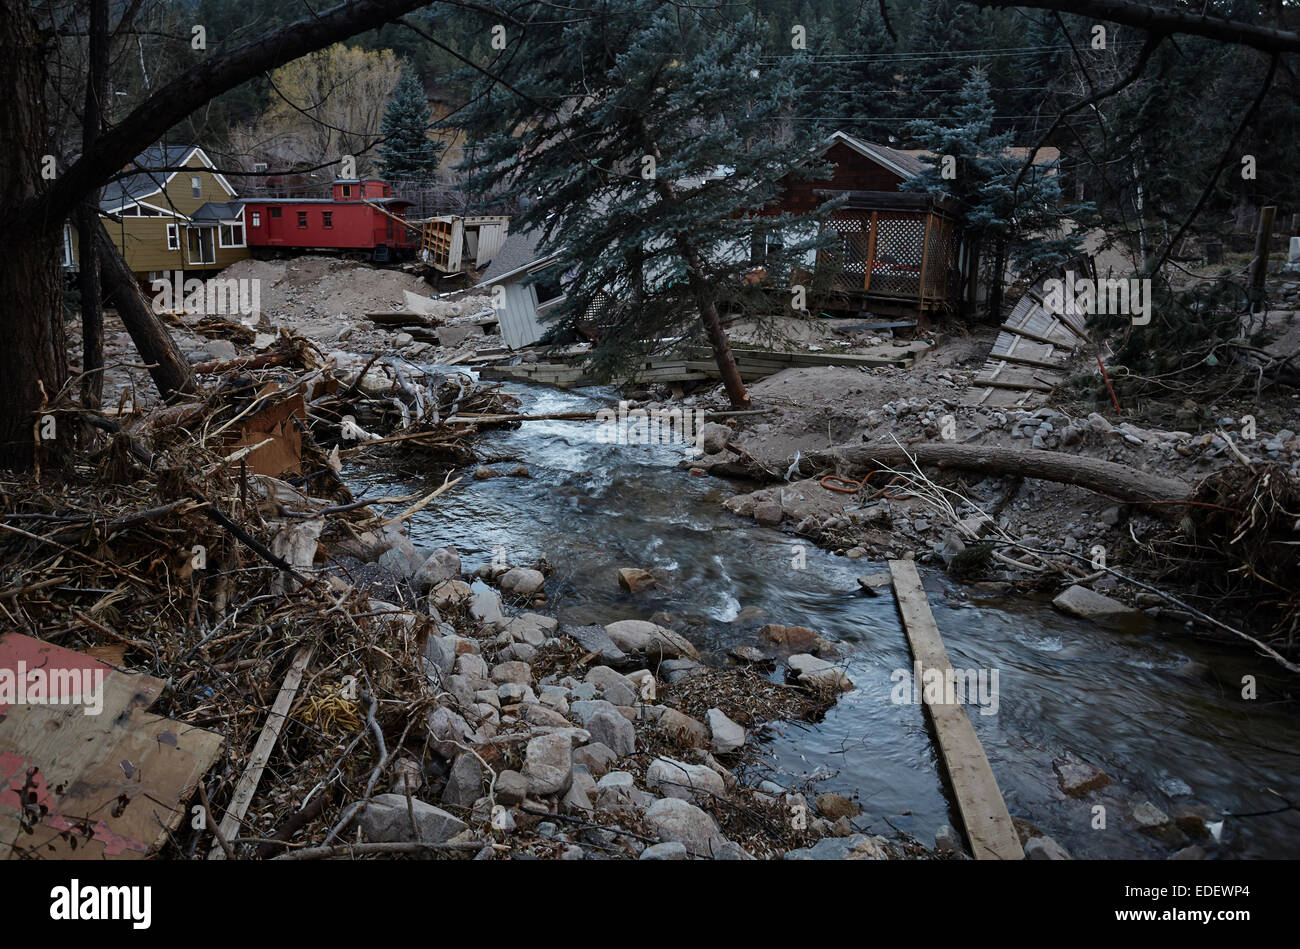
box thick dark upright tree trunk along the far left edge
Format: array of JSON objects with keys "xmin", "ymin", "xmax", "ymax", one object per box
[{"xmin": 0, "ymin": 0, "xmax": 70, "ymax": 469}]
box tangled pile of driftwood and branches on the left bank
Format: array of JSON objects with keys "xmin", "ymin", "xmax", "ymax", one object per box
[{"xmin": 0, "ymin": 335, "xmax": 522, "ymax": 857}]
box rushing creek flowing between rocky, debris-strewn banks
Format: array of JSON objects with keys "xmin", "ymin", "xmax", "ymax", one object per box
[{"xmin": 348, "ymin": 371, "xmax": 1300, "ymax": 858}]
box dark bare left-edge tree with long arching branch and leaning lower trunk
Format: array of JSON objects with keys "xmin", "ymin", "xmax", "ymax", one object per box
[{"xmin": 0, "ymin": 0, "xmax": 517, "ymax": 469}]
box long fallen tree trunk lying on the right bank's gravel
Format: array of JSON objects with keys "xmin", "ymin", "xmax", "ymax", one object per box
[{"xmin": 789, "ymin": 442, "xmax": 1192, "ymax": 504}]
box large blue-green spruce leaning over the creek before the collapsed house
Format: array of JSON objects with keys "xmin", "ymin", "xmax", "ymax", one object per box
[{"xmin": 462, "ymin": 0, "xmax": 828, "ymax": 404}]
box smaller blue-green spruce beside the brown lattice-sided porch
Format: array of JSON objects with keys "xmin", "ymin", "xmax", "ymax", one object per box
[{"xmin": 902, "ymin": 69, "xmax": 1091, "ymax": 317}]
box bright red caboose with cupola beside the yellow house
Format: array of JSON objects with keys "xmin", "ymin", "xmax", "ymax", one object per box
[{"xmin": 243, "ymin": 178, "xmax": 420, "ymax": 261}]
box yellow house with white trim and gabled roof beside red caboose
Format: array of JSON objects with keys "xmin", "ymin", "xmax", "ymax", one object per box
[{"xmin": 64, "ymin": 146, "xmax": 248, "ymax": 281}]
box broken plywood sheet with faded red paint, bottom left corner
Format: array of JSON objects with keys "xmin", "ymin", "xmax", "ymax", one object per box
[{"xmin": 0, "ymin": 633, "xmax": 222, "ymax": 859}]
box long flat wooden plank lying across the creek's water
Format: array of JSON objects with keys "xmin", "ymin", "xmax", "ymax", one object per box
[{"xmin": 889, "ymin": 560, "xmax": 1024, "ymax": 861}]
